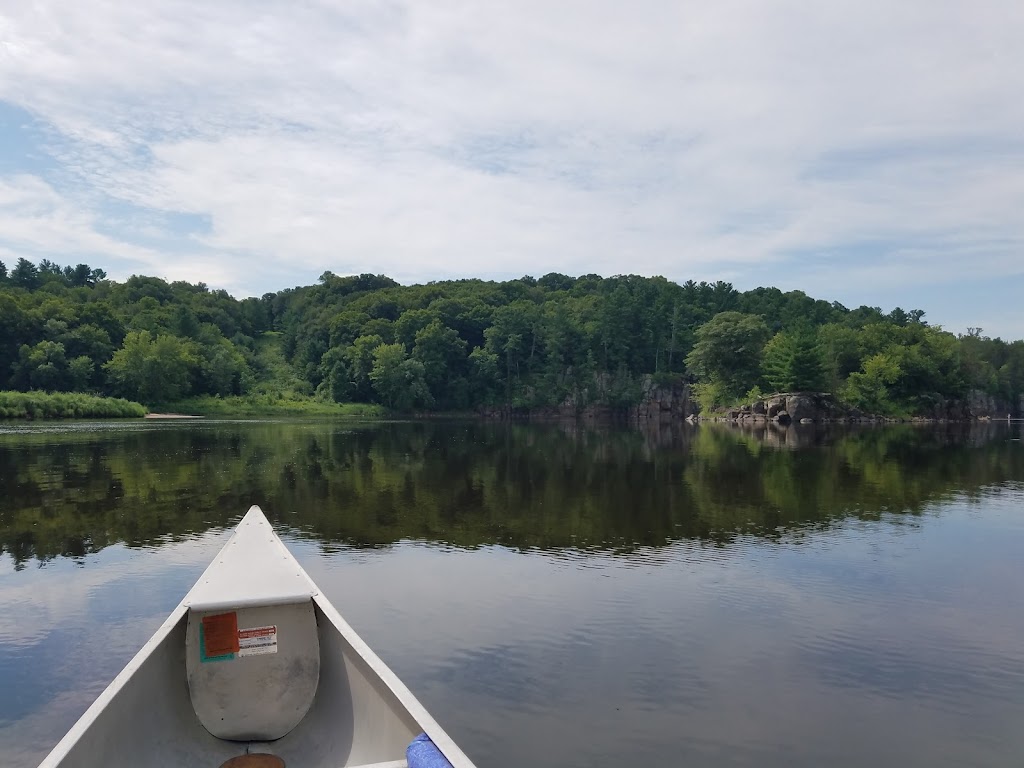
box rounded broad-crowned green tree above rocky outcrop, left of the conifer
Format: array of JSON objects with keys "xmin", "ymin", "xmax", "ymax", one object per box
[{"xmin": 686, "ymin": 311, "xmax": 768, "ymax": 397}]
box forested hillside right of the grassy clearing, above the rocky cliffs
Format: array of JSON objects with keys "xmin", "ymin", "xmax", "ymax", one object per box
[{"xmin": 272, "ymin": 272, "xmax": 1024, "ymax": 416}]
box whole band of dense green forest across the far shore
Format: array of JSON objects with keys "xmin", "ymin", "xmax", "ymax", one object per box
[{"xmin": 0, "ymin": 259, "xmax": 1024, "ymax": 416}]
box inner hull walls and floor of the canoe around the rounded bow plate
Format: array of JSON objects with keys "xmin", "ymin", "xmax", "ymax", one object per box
[{"xmin": 44, "ymin": 596, "xmax": 423, "ymax": 768}]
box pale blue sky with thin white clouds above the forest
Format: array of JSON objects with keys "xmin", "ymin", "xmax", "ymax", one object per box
[{"xmin": 0, "ymin": 0, "xmax": 1024, "ymax": 338}]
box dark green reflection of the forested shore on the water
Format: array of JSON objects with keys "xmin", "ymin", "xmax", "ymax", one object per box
[{"xmin": 0, "ymin": 422, "xmax": 1024, "ymax": 567}]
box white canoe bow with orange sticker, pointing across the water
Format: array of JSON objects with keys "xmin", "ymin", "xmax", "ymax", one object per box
[{"xmin": 40, "ymin": 507, "xmax": 473, "ymax": 768}]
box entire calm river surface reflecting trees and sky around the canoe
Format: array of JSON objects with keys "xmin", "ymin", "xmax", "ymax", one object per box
[{"xmin": 0, "ymin": 422, "xmax": 1024, "ymax": 768}]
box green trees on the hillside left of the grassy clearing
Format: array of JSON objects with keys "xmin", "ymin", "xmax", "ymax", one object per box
[{"xmin": 0, "ymin": 259, "xmax": 272, "ymax": 404}]
